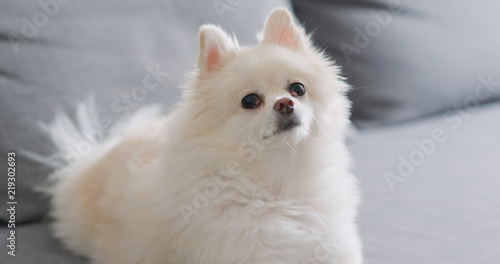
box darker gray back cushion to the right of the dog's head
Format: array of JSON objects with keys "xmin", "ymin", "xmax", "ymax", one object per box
[{"xmin": 292, "ymin": 0, "xmax": 500, "ymax": 127}]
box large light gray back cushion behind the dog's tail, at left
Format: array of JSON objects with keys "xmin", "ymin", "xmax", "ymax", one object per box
[{"xmin": 0, "ymin": 0, "xmax": 288, "ymax": 223}]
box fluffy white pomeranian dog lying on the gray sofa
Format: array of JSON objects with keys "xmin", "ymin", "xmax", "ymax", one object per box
[{"xmin": 46, "ymin": 8, "xmax": 362, "ymax": 264}]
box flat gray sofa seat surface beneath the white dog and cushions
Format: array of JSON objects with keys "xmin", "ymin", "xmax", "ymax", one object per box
[{"xmin": 0, "ymin": 100, "xmax": 500, "ymax": 264}]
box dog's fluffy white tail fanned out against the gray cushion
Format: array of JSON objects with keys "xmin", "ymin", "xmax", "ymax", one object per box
[{"xmin": 22, "ymin": 96, "xmax": 162, "ymax": 185}]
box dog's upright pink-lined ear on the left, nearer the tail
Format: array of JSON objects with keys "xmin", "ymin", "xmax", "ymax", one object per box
[{"xmin": 198, "ymin": 25, "xmax": 239, "ymax": 72}]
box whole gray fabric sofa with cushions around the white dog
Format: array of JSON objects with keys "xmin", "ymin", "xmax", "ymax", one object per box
[{"xmin": 0, "ymin": 0, "xmax": 500, "ymax": 264}]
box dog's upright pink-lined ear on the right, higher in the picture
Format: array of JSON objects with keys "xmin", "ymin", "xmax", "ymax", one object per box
[{"xmin": 261, "ymin": 8, "xmax": 308, "ymax": 50}]
